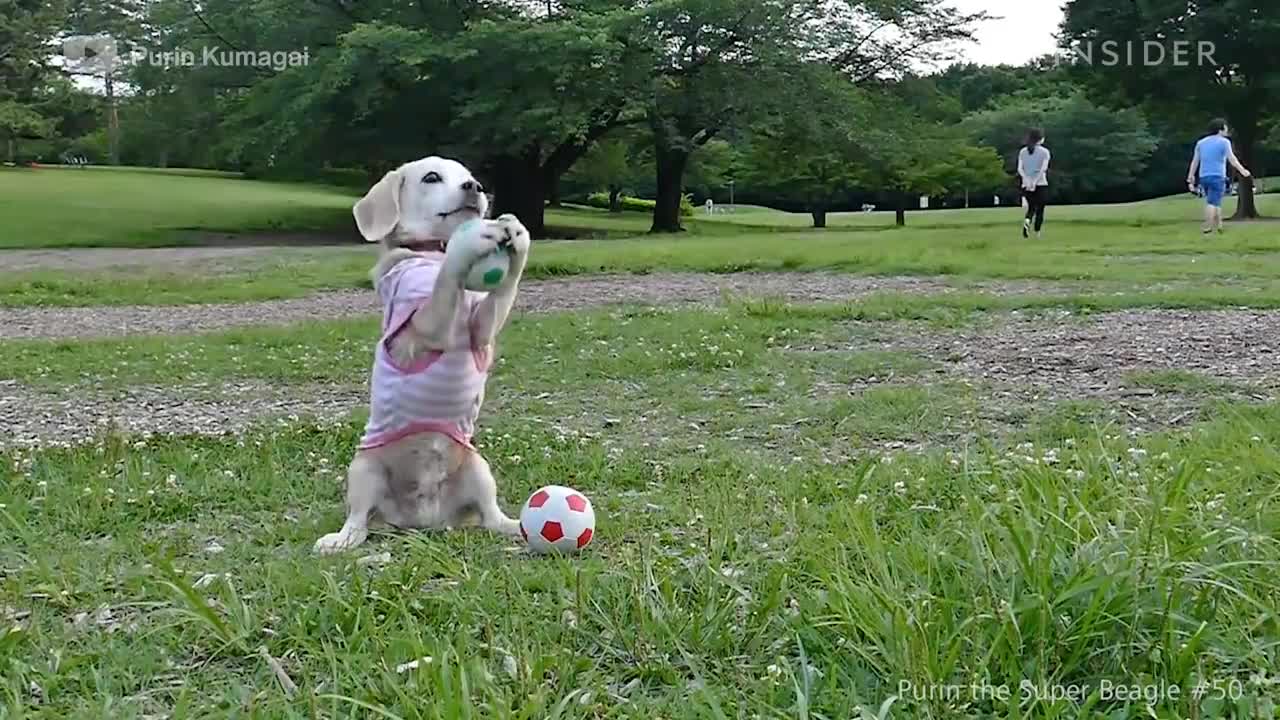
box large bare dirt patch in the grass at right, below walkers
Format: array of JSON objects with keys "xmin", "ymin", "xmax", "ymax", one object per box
[{"xmin": 886, "ymin": 310, "xmax": 1280, "ymax": 430}]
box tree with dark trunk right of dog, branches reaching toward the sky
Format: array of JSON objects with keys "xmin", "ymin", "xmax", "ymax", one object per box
[{"xmin": 634, "ymin": 0, "xmax": 987, "ymax": 232}]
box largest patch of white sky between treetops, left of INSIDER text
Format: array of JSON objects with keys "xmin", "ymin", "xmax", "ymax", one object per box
[{"xmin": 950, "ymin": 0, "xmax": 1064, "ymax": 65}]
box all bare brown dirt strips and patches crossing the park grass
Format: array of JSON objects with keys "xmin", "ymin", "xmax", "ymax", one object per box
[{"xmin": 0, "ymin": 238, "xmax": 1280, "ymax": 445}]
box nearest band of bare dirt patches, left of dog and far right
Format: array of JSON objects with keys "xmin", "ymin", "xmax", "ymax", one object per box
[{"xmin": 0, "ymin": 304, "xmax": 1280, "ymax": 446}]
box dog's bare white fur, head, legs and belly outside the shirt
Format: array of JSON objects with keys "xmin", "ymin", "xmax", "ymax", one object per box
[{"xmin": 315, "ymin": 156, "xmax": 529, "ymax": 553}]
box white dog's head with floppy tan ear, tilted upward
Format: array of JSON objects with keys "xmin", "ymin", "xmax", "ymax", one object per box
[{"xmin": 352, "ymin": 155, "xmax": 489, "ymax": 249}]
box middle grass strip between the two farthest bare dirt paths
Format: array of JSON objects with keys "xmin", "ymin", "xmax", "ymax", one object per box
[{"xmin": 0, "ymin": 209, "xmax": 1280, "ymax": 306}]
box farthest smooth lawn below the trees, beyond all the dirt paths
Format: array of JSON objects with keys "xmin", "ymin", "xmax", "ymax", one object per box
[{"xmin": 0, "ymin": 167, "xmax": 1280, "ymax": 249}]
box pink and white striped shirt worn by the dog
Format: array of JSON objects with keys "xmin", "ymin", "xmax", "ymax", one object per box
[{"xmin": 360, "ymin": 252, "xmax": 490, "ymax": 450}]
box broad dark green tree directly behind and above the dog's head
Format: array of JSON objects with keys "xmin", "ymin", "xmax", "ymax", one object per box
[{"xmin": 205, "ymin": 0, "xmax": 643, "ymax": 237}]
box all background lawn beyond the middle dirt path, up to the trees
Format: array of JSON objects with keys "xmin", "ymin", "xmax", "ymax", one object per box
[{"xmin": 0, "ymin": 168, "xmax": 1280, "ymax": 306}]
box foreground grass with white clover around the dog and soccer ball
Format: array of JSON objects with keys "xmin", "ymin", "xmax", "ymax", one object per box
[{"xmin": 0, "ymin": 304, "xmax": 1280, "ymax": 719}]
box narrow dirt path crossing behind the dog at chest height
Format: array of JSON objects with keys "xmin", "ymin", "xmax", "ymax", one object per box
[{"xmin": 0, "ymin": 273, "xmax": 1061, "ymax": 340}]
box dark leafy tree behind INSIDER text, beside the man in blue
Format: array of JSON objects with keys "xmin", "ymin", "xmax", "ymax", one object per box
[{"xmin": 1062, "ymin": 0, "xmax": 1280, "ymax": 219}]
